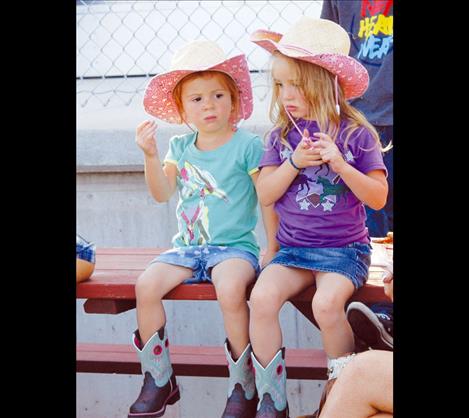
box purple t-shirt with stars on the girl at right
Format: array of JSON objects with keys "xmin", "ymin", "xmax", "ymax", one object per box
[{"xmin": 259, "ymin": 119, "xmax": 387, "ymax": 248}]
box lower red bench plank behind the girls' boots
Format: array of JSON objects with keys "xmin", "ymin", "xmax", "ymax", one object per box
[{"xmin": 76, "ymin": 343, "xmax": 327, "ymax": 380}]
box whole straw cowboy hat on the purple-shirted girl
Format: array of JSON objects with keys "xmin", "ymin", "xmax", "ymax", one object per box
[{"xmin": 250, "ymin": 16, "xmax": 369, "ymax": 99}]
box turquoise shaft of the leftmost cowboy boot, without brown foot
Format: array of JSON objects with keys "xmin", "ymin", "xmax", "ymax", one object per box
[{"xmin": 132, "ymin": 329, "xmax": 173, "ymax": 387}]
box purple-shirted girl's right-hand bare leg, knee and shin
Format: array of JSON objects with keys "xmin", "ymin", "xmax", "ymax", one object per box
[{"xmin": 312, "ymin": 272, "xmax": 355, "ymax": 358}]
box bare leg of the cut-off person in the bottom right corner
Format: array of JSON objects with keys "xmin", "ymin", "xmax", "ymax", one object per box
[{"xmin": 320, "ymin": 350, "xmax": 393, "ymax": 418}]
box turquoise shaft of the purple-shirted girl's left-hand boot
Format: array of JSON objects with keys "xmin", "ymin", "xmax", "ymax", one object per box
[{"xmin": 251, "ymin": 350, "xmax": 287, "ymax": 411}]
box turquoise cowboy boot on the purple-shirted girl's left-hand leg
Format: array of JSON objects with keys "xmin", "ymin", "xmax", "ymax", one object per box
[{"xmin": 251, "ymin": 348, "xmax": 289, "ymax": 418}]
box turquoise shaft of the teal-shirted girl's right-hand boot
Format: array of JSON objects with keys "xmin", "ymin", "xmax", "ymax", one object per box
[{"xmin": 225, "ymin": 342, "xmax": 256, "ymax": 400}]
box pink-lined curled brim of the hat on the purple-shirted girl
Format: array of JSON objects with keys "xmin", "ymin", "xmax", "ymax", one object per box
[{"xmin": 250, "ymin": 30, "xmax": 370, "ymax": 99}]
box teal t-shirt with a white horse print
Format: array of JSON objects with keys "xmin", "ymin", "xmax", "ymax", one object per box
[{"xmin": 164, "ymin": 129, "xmax": 263, "ymax": 257}]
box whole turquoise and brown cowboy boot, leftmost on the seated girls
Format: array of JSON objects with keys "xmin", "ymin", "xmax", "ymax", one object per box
[{"xmin": 128, "ymin": 326, "xmax": 180, "ymax": 418}]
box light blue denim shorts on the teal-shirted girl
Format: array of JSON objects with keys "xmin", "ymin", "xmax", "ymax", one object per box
[{"xmin": 150, "ymin": 245, "xmax": 260, "ymax": 283}]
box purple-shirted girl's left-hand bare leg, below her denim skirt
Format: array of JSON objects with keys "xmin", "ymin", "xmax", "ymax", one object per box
[{"xmin": 249, "ymin": 264, "xmax": 314, "ymax": 367}]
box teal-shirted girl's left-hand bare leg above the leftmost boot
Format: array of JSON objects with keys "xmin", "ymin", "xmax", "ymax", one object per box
[{"xmin": 135, "ymin": 263, "xmax": 192, "ymax": 344}]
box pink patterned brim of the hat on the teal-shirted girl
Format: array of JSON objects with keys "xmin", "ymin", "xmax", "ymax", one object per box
[{"xmin": 143, "ymin": 54, "xmax": 253, "ymax": 124}]
